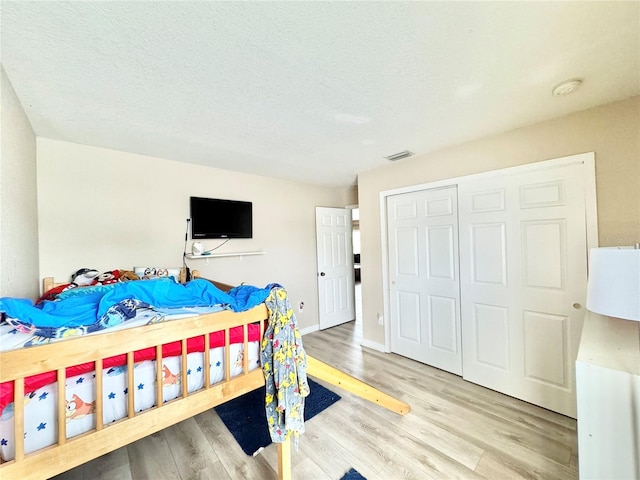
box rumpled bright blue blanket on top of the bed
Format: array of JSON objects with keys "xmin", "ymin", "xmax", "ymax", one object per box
[{"xmin": 0, "ymin": 278, "xmax": 279, "ymax": 338}]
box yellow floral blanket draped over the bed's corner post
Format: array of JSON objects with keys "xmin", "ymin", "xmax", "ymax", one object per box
[{"xmin": 260, "ymin": 287, "xmax": 309, "ymax": 449}]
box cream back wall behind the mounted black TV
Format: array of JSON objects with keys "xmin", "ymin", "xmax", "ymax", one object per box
[{"xmin": 37, "ymin": 138, "xmax": 354, "ymax": 328}]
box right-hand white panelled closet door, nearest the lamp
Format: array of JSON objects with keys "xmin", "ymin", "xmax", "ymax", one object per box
[{"xmin": 458, "ymin": 164, "xmax": 587, "ymax": 418}]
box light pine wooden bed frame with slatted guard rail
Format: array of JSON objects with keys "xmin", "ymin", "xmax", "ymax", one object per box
[{"xmin": 0, "ymin": 278, "xmax": 410, "ymax": 480}]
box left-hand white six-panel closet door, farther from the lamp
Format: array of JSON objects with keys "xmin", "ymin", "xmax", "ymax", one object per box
[{"xmin": 387, "ymin": 186, "xmax": 462, "ymax": 375}]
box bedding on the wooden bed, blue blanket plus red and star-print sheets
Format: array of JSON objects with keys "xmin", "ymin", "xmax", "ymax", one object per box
[{"xmin": 0, "ymin": 278, "xmax": 272, "ymax": 461}]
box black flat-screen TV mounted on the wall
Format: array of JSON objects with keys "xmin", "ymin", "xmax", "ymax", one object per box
[{"xmin": 191, "ymin": 197, "xmax": 253, "ymax": 240}]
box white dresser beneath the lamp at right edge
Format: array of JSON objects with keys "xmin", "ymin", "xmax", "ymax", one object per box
[{"xmin": 576, "ymin": 312, "xmax": 640, "ymax": 480}]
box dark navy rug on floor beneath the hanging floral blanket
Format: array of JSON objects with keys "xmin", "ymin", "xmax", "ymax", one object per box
[{"xmin": 215, "ymin": 378, "xmax": 340, "ymax": 454}]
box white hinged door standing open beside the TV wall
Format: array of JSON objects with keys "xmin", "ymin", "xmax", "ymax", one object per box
[{"xmin": 316, "ymin": 207, "xmax": 356, "ymax": 330}]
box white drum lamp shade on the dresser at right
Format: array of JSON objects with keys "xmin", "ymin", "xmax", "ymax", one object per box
[{"xmin": 587, "ymin": 247, "xmax": 640, "ymax": 322}]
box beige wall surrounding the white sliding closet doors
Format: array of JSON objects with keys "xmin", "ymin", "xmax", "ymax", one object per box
[{"xmin": 358, "ymin": 97, "xmax": 640, "ymax": 344}]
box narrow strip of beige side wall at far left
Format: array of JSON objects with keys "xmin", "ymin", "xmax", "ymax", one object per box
[{"xmin": 0, "ymin": 68, "xmax": 39, "ymax": 298}]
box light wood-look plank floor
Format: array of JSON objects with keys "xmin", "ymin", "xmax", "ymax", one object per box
[{"xmin": 55, "ymin": 322, "xmax": 578, "ymax": 480}]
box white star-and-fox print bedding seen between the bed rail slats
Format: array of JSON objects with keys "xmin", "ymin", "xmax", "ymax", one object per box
[{"xmin": 0, "ymin": 340, "xmax": 260, "ymax": 461}]
